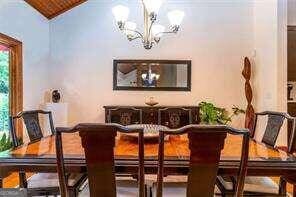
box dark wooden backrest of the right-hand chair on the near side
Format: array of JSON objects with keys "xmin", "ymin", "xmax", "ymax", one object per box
[{"xmin": 157, "ymin": 125, "xmax": 249, "ymax": 197}]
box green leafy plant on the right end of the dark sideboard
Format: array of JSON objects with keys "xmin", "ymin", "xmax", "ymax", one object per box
[{"xmin": 198, "ymin": 101, "xmax": 245, "ymax": 124}]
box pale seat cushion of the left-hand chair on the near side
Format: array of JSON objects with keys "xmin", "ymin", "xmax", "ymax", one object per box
[{"xmin": 79, "ymin": 178, "xmax": 139, "ymax": 197}]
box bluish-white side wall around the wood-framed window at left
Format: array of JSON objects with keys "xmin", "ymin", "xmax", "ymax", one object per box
[{"xmin": 0, "ymin": 0, "xmax": 50, "ymax": 109}]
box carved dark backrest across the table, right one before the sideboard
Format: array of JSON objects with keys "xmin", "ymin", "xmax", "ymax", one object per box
[{"xmin": 158, "ymin": 107, "xmax": 192, "ymax": 129}]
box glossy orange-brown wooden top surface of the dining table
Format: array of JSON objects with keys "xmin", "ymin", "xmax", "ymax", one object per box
[{"xmin": 0, "ymin": 133, "xmax": 296, "ymax": 162}]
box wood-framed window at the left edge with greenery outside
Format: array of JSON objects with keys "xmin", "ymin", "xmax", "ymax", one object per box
[{"xmin": 0, "ymin": 33, "xmax": 23, "ymax": 148}]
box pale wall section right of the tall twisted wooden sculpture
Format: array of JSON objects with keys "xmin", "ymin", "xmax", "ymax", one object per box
[{"xmin": 253, "ymin": 0, "xmax": 287, "ymax": 145}]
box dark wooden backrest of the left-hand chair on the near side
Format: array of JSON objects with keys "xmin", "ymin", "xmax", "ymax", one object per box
[{"xmin": 56, "ymin": 124, "xmax": 145, "ymax": 197}]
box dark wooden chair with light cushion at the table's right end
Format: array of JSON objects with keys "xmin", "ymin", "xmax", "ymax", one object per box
[{"xmin": 217, "ymin": 111, "xmax": 295, "ymax": 196}]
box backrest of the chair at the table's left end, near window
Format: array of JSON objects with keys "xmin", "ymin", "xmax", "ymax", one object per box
[{"xmin": 10, "ymin": 110, "xmax": 55, "ymax": 146}]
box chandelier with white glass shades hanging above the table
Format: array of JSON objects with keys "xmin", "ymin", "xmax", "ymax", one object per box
[{"xmin": 112, "ymin": 0, "xmax": 184, "ymax": 49}]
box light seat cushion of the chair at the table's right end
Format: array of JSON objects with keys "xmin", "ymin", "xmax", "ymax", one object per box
[{"xmin": 218, "ymin": 176, "xmax": 279, "ymax": 194}]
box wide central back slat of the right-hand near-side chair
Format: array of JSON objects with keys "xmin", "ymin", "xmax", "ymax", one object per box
[{"xmin": 187, "ymin": 132, "xmax": 226, "ymax": 197}]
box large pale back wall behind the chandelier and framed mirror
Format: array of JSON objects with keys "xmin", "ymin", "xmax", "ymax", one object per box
[{"xmin": 50, "ymin": 0, "xmax": 253, "ymax": 125}]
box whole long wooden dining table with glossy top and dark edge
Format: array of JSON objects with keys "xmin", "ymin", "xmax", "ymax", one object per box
[{"xmin": 0, "ymin": 133, "xmax": 296, "ymax": 186}]
